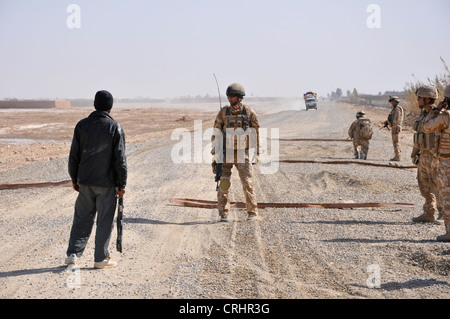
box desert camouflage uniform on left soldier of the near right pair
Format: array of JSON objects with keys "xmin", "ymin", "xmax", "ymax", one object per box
[{"xmin": 411, "ymin": 109, "xmax": 439, "ymax": 221}]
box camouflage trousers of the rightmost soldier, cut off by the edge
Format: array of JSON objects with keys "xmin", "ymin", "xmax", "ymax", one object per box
[{"xmin": 433, "ymin": 158, "xmax": 450, "ymax": 223}]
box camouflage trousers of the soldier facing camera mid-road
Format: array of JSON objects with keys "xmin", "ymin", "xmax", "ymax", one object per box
[{"xmin": 217, "ymin": 155, "xmax": 258, "ymax": 217}]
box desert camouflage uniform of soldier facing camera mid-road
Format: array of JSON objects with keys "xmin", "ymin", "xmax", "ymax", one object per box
[{"xmin": 213, "ymin": 104, "xmax": 259, "ymax": 218}]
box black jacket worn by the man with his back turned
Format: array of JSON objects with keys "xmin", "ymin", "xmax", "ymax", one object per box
[{"xmin": 69, "ymin": 111, "xmax": 127, "ymax": 189}]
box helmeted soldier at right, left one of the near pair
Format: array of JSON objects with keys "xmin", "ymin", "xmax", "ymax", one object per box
[{"xmin": 411, "ymin": 85, "xmax": 439, "ymax": 223}]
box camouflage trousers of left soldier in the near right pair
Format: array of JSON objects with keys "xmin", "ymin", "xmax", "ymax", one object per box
[{"xmin": 417, "ymin": 152, "xmax": 438, "ymax": 216}]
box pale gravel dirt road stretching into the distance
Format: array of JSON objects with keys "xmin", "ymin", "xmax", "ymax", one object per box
[{"xmin": 0, "ymin": 102, "xmax": 450, "ymax": 299}]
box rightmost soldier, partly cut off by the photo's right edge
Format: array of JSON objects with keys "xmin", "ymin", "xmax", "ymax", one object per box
[{"xmin": 423, "ymin": 85, "xmax": 450, "ymax": 242}]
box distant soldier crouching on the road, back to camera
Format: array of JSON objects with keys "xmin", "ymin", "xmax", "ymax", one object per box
[{"xmin": 348, "ymin": 111, "xmax": 373, "ymax": 160}]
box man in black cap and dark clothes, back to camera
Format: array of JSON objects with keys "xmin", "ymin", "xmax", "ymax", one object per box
[{"xmin": 65, "ymin": 91, "xmax": 127, "ymax": 269}]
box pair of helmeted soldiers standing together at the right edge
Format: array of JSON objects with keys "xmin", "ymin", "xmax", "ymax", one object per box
[{"xmin": 411, "ymin": 85, "xmax": 450, "ymax": 241}]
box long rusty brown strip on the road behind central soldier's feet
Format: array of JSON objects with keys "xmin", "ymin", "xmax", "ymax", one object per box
[{"xmin": 169, "ymin": 198, "xmax": 414, "ymax": 209}]
